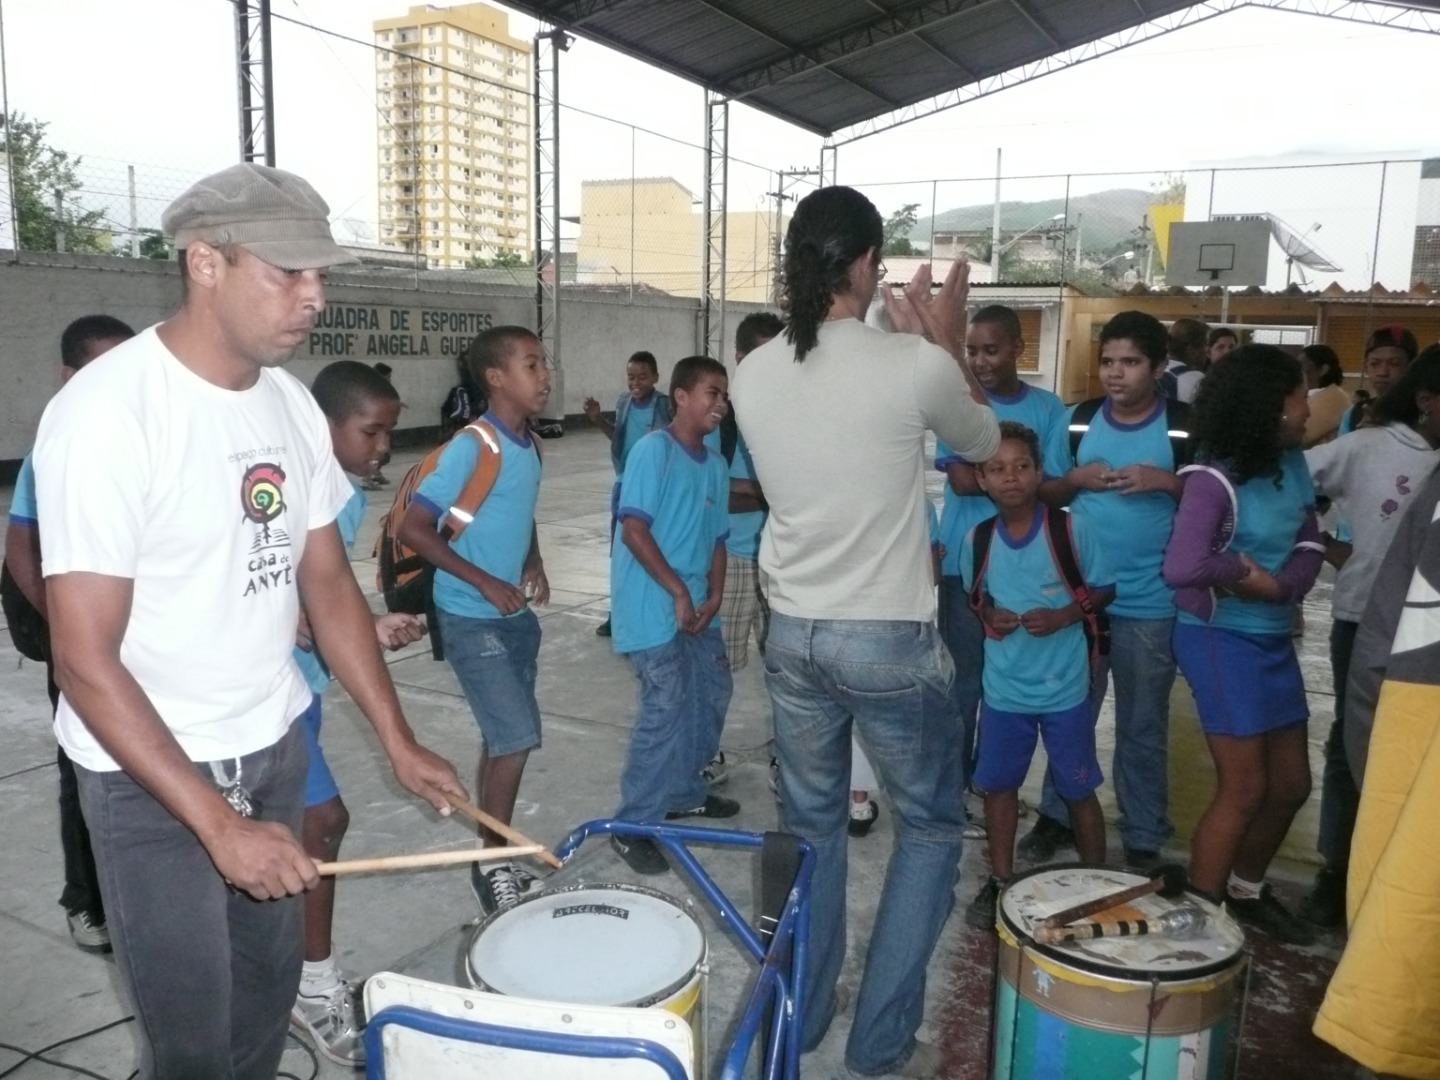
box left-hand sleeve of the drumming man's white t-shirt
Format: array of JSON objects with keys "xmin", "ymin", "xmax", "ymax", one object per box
[{"xmin": 35, "ymin": 385, "xmax": 151, "ymax": 579}]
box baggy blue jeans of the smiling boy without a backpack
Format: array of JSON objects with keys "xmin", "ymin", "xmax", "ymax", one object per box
[{"xmin": 615, "ymin": 624, "xmax": 733, "ymax": 822}]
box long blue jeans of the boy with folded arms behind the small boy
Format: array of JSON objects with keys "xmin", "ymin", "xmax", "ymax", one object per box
[{"xmin": 1040, "ymin": 615, "xmax": 1175, "ymax": 851}]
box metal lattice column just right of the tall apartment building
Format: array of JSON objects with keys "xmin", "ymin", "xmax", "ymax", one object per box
[{"xmin": 531, "ymin": 30, "xmax": 575, "ymax": 418}]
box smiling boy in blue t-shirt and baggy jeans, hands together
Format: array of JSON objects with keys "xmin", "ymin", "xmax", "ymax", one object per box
[{"xmin": 611, "ymin": 356, "xmax": 740, "ymax": 874}]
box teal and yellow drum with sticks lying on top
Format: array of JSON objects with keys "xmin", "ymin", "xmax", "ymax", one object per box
[{"xmin": 992, "ymin": 865, "xmax": 1247, "ymax": 1080}]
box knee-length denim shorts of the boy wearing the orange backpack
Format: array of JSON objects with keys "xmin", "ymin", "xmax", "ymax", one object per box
[{"xmin": 438, "ymin": 608, "xmax": 540, "ymax": 757}]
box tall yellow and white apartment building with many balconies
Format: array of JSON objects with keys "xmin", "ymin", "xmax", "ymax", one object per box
[{"xmin": 374, "ymin": 4, "xmax": 533, "ymax": 268}]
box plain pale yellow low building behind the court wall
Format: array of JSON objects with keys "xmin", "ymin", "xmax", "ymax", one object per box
[{"xmin": 576, "ymin": 176, "xmax": 789, "ymax": 304}]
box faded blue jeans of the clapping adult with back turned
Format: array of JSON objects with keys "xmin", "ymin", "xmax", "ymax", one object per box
[{"xmin": 765, "ymin": 612, "xmax": 965, "ymax": 1074}]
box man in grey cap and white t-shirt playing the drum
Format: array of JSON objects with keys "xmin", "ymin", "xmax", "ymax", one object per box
[{"xmin": 35, "ymin": 164, "xmax": 464, "ymax": 1080}]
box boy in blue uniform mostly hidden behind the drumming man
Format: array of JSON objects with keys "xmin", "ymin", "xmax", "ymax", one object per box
[{"xmin": 291, "ymin": 360, "xmax": 425, "ymax": 1067}]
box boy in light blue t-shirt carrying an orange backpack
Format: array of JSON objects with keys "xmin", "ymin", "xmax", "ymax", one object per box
[{"xmin": 399, "ymin": 327, "xmax": 550, "ymax": 914}]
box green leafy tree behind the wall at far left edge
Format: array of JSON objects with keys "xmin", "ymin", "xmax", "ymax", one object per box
[{"xmin": 0, "ymin": 112, "xmax": 111, "ymax": 253}]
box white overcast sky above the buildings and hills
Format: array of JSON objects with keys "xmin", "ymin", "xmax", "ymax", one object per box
[{"xmin": 3, "ymin": 0, "xmax": 1440, "ymax": 235}]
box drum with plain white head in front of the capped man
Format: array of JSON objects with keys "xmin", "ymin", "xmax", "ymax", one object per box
[{"xmin": 465, "ymin": 884, "xmax": 707, "ymax": 1061}]
